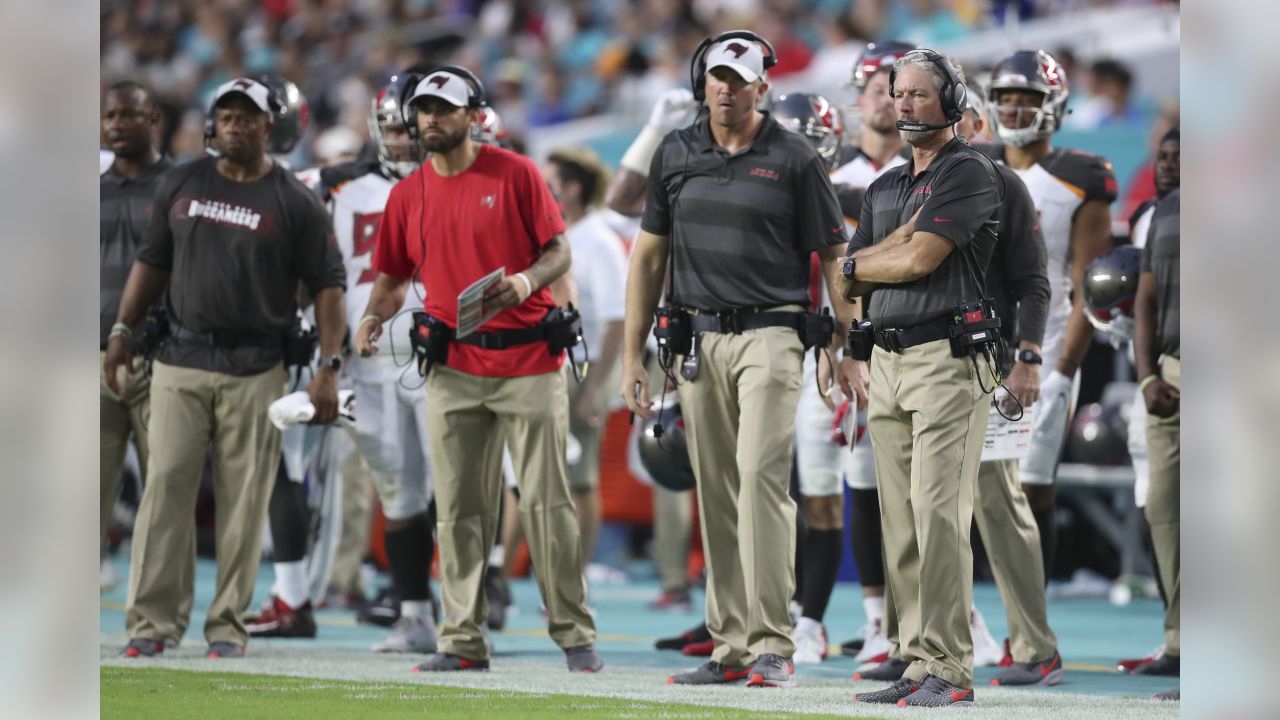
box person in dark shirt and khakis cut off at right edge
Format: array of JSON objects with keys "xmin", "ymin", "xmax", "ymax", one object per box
[{"xmin": 1133, "ymin": 190, "xmax": 1183, "ymax": 700}]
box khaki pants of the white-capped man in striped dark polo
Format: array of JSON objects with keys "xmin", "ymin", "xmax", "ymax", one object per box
[{"xmin": 680, "ymin": 328, "xmax": 804, "ymax": 665}]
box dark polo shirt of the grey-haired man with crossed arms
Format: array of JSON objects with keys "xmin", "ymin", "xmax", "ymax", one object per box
[{"xmin": 849, "ymin": 140, "xmax": 1004, "ymax": 328}]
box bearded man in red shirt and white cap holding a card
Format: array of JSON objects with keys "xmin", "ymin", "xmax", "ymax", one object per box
[{"xmin": 356, "ymin": 65, "xmax": 604, "ymax": 673}]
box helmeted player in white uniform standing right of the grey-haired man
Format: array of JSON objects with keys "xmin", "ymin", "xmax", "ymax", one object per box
[{"xmin": 984, "ymin": 50, "xmax": 1116, "ymax": 579}]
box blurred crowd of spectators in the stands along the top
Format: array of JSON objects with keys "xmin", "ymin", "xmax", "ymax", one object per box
[{"xmin": 101, "ymin": 0, "xmax": 1176, "ymax": 165}]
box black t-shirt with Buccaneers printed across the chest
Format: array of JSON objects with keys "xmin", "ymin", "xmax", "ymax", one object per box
[{"xmin": 138, "ymin": 158, "xmax": 346, "ymax": 375}]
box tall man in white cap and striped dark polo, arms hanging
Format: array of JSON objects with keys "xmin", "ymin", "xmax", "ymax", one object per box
[{"xmin": 621, "ymin": 32, "xmax": 851, "ymax": 685}]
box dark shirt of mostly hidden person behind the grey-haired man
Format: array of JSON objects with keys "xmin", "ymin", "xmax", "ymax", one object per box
[{"xmin": 987, "ymin": 165, "xmax": 1050, "ymax": 348}]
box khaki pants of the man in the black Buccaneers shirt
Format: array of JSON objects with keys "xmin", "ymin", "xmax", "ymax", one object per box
[{"xmin": 124, "ymin": 363, "xmax": 288, "ymax": 644}]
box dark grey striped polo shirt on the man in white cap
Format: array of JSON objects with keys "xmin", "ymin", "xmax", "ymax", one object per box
[{"xmin": 640, "ymin": 113, "xmax": 846, "ymax": 311}]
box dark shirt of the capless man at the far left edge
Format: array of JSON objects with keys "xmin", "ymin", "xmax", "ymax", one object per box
[{"xmin": 97, "ymin": 159, "xmax": 173, "ymax": 347}]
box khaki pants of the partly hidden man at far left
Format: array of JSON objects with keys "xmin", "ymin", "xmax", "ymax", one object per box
[{"xmin": 97, "ymin": 352, "xmax": 151, "ymax": 555}]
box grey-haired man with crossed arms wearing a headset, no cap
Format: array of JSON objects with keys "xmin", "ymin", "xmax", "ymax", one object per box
[{"xmin": 846, "ymin": 50, "xmax": 1004, "ymax": 706}]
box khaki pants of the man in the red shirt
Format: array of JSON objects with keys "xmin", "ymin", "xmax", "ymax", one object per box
[{"xmin": 426, "ymin": 366, "xmax": 595, "ymax": 660}]
